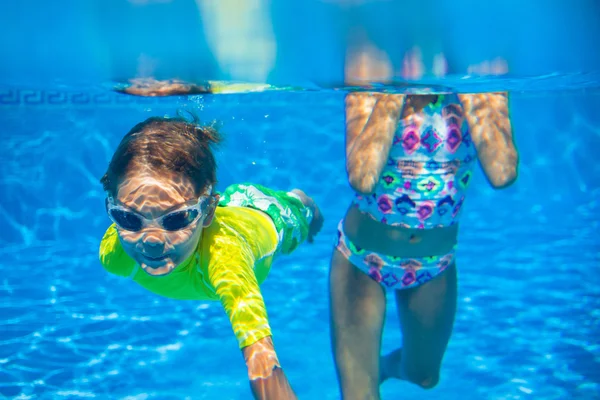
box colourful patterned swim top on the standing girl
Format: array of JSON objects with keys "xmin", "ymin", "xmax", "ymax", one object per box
[{"xmin": 354, "ymin": 95, "xmax": 477, "ymax": 229}]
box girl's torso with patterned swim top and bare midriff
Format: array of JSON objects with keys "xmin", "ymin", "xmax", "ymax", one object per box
[{"xmin": 344, "ymin": 95, "xmax": 477, "ymax": 256}]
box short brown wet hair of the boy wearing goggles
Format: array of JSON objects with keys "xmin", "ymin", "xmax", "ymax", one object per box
[{"xmin": 100, "ymin": 113, "xmax": 221, "ymax": 196}]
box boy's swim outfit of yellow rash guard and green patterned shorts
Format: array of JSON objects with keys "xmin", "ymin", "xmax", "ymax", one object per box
[{"xmin": 100, "ymin": 185, "xmax": 312, "ymax": 348}]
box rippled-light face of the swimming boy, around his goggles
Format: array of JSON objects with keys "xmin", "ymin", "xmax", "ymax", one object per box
[{"xmin": 114, "ymin": 171, "xmax": 215, "ymax": 276}]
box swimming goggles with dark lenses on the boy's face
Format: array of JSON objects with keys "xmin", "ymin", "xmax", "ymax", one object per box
[{"xmin": 106, "ymin": 188, "xmax": 214, "ymax": 232}]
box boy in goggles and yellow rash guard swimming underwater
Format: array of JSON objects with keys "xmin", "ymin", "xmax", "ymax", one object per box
[{"xmin": 100, "ymin": 117, "xmax": 323, "ymax": 399}]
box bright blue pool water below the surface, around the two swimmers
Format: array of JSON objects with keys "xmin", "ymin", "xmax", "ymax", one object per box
[{"xmin": 0, "ymin": 82, "xmax": 600, "ymax": 400}]
